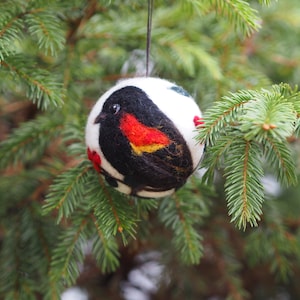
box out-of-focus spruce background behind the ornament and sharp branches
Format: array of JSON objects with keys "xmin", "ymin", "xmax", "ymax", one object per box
[{"xmin": 0, "ymin": 0, "xmax": 300, "ymax": 300}]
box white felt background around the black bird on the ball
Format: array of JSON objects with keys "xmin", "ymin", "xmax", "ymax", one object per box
[{"xmin": 86, "ymin": 77, "xmax": 204, "ymax": 197}]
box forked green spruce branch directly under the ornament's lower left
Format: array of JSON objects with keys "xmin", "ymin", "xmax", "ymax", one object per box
[{"xmin": 44, "ymin": 160, "xmax": 137, "ymax": 244}]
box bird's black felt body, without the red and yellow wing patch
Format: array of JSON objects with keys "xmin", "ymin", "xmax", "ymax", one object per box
[{"xmin": 96, "ymin": 86, "xmax": 193, "ymax": 194}]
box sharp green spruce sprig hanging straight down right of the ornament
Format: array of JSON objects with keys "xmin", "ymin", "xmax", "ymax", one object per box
[{"xmin": 225, "ymin": 140, "xmax": 264, "ymax": 229}]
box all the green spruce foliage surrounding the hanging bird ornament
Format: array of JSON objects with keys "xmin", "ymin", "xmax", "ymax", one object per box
[{"xmin": 0, "ymin": 0, "xmax": 300, "ymax": 300}]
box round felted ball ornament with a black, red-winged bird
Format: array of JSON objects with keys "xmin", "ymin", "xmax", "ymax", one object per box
[{"xmin": 86, "ymin": 77, "xmax": 204, "ymax": 198}]
